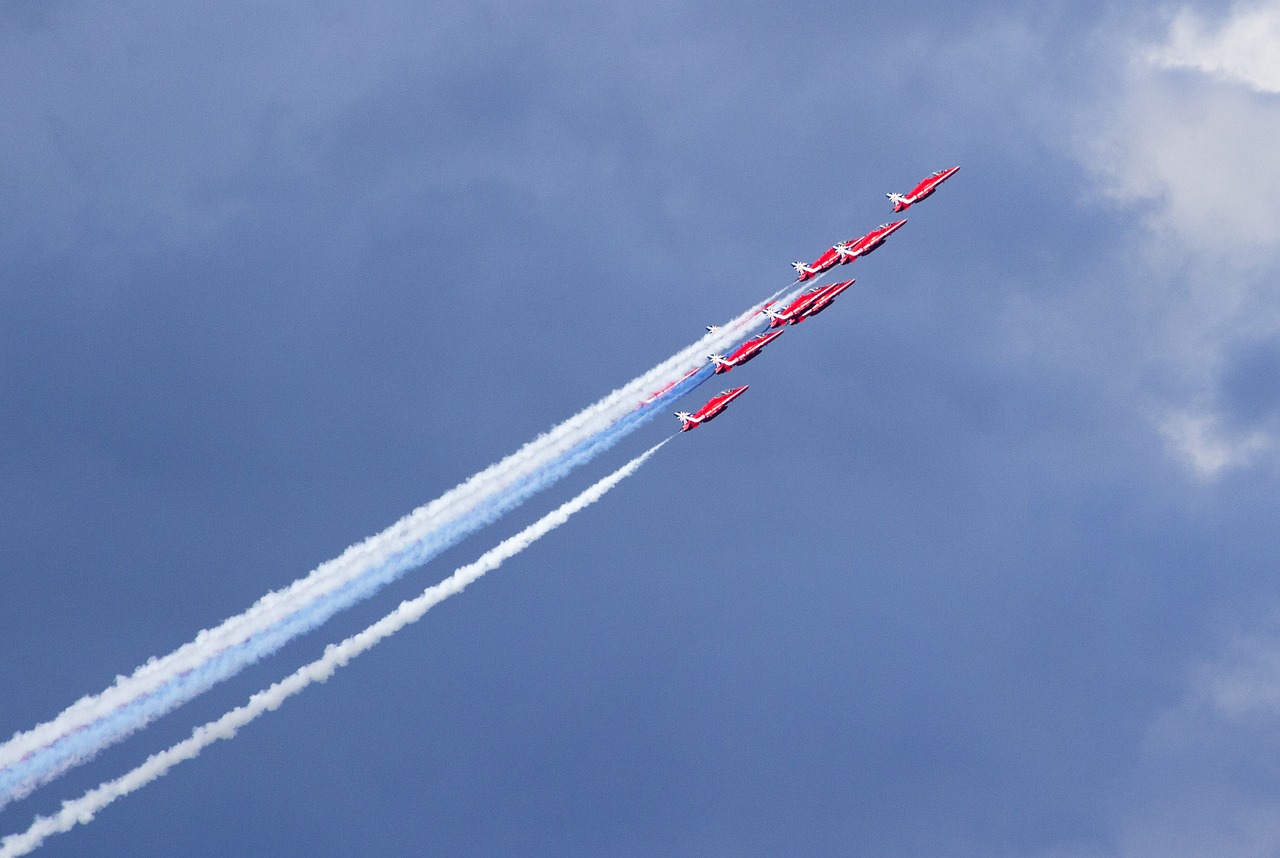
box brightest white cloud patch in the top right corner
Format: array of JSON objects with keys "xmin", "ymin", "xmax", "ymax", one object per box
[{"xmin": 1148, "ymin": 4, "xmax": 1280, "ymax": 93}]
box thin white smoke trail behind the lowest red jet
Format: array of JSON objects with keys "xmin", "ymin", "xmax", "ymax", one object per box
[{"xmin": 0, "ymin": 438, "xmax": 671, "ymax": 858}]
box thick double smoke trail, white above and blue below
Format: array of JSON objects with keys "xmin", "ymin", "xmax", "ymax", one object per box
[{"xmin": 0, "ymin": 282, "xmax": 813, "ymax": 808}]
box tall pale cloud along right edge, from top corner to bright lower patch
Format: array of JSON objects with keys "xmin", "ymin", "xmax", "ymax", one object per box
[{"xmin": 1078, "ymin": 4, "xmax": 1280, "ymax": 479}]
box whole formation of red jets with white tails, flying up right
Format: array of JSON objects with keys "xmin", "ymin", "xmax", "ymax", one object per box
[{"xmin": 665, "ymin": 166, "xmax": 960, "ymax": 432}]
